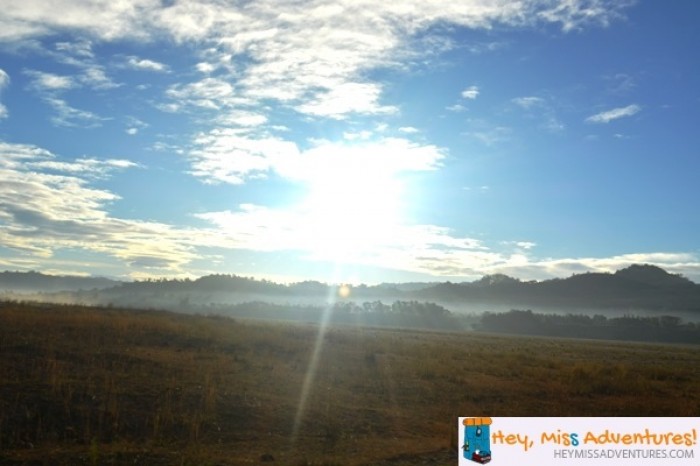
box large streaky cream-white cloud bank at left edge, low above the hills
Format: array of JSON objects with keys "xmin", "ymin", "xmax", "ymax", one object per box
[{"xmin": 0, "ymin": 141, "xmax": 200, "ymax": 270}]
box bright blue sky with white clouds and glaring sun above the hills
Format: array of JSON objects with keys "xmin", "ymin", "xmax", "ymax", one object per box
[{"xmin": 0, "ymin": 0, "xmax": 700, "ymax": 284}]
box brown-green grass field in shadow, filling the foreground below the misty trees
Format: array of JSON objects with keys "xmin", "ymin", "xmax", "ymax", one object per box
[{"xmin": 0, "ymin": 303, "xmax": 700, "ymax": 466}]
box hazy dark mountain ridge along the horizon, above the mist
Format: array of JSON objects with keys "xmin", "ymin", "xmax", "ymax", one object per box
[{"xmin": 0, "ymin": 264, "xmax": 700, "ymax": 313}]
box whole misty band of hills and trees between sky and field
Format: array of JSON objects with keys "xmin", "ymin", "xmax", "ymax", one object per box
[{"xmin": 0, "ymin": 265, "xmax": 700, "ymax": 343}]
